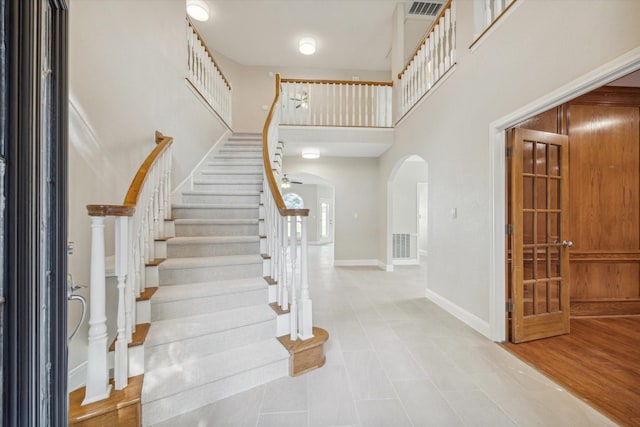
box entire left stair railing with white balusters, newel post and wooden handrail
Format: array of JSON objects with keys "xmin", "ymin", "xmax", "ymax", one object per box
[{"xmin": 82, "ymin": 132, "xmax": 173, "ymax": 405}]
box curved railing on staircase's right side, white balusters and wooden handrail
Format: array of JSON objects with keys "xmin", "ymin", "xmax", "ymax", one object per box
[{"xmin": 262, "ymin": 75, "xmax": 313, "ymax": 341}]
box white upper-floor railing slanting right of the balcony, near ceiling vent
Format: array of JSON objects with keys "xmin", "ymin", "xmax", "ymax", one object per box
[{"xmin": 398, "ymin": 0, "xmax": 456, "ymax": 118}]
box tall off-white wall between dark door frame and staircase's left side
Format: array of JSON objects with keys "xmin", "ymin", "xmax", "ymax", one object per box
[{"xmin": 69, "ymin": 0, "xmax": 226, "ymax": 387}]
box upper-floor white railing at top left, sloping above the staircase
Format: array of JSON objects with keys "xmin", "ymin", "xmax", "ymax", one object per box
[{"xmin": 187, "ymin": 18, "xmax": 231, "ymax": 128}]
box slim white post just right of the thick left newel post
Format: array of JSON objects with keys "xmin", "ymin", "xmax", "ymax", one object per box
[{"xmin": 113, "ymin": 216, "xmax": 129, "ymax": 390}]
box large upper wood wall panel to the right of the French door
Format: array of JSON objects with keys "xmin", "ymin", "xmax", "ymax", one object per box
[{"xmin": 569, "ymin": 105, "xmax": 640, "ymax": 253}]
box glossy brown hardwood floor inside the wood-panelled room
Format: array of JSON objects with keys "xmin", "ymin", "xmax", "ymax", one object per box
[{"xmin": 504, "ymin": 316, "xmax": 640, "ymax": 426}]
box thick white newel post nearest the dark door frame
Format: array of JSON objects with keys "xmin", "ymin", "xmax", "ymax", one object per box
[{"xmin": 82, "ymin": 216, "xmax": 111, "ymax": 405}]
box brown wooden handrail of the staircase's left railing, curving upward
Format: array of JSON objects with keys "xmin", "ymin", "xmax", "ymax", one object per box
[{"xmin": 87, "ymin": 131, "xmax": 173, "ymax": 216}]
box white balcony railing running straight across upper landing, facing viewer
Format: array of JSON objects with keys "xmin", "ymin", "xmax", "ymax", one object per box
[{"xmin": 280, "ymin": 79, "xmax": 393, "ymax": 127}]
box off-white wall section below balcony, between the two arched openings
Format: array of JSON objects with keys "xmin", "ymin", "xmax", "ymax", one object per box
[{"xmin": 283, "ymin": 156, "xmax": 379, "ymax": 264}]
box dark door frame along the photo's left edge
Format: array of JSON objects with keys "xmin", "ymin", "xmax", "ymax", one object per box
[{"xmin": 0, "ymin": 0, "xmax": 68, "ymax": 426}]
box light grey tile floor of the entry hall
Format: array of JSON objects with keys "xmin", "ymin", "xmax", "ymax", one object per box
[{"xmin": 152, "ymin": 245, "xmax": 615, "ymax": 427}]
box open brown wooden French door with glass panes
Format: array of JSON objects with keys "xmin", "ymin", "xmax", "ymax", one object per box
[{"xmin": 508, "ymin": 128, "xmax": 573, "ymax": 342}]
